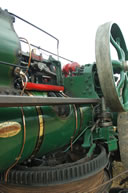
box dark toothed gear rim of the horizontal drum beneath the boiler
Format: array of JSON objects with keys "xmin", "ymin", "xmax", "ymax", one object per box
[{"xmin": 0, "ymin": 146, "xmax": 109, "ymax": 187}]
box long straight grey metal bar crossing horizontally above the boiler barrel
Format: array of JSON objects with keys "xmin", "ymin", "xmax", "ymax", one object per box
[{"xmin": 0, "ymin": 95, "xmax": 101, "ymax": 107}]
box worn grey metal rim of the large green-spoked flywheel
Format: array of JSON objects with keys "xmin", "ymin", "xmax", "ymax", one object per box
[{"xmin": 95, "ymin": 22, "xmax": 128, "ymax": 112}]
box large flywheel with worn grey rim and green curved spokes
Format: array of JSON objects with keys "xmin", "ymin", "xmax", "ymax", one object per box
[{"xmin": 95, "ymin": 22, "xmax": 128, "ymax": 112}]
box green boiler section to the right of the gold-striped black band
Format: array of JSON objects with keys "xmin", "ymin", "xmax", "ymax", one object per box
[{"xmin": 38, "ymin": 106, "xmax": 92, "ymax": 156}]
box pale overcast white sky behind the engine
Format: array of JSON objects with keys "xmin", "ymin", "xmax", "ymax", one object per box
[{"xmin": 0, "ymin": 0, "xmax": 128, "ymax": 64}]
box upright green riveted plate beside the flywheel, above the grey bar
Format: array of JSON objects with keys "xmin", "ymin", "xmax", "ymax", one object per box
[{"xmin": 64, "ymin": 64, "xmax": 98, "ymax": 98}]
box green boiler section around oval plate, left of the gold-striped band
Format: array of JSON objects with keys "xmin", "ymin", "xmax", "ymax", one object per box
[{"xmin": 0, "ymin": 107, "xmax": 38, "ymax": 170}]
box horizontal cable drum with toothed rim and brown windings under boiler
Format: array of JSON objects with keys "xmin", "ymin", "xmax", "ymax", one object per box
[{"xmin": 1, "ymin": 147, "xmax": 109, "ymax": 193}]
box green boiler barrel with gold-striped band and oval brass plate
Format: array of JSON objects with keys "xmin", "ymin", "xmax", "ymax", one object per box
[{"xmin": 0, "ymin": 94, "xmax": 92, "ymax": 171}]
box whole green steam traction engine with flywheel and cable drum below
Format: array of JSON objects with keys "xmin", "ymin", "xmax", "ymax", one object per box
[{"xmin": 0, "ymin": 9, "xmax": 128, "ymax": 193}]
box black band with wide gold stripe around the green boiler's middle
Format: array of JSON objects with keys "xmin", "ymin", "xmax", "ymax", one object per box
[{"xmin": 25, "ymin": 91, "xmax": 44, "ymax": 159}]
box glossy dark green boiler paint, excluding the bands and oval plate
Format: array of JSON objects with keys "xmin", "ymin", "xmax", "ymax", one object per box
[{"xmin": 0, "ymin": 89, "xmax": 92, "ymax": 171}]
